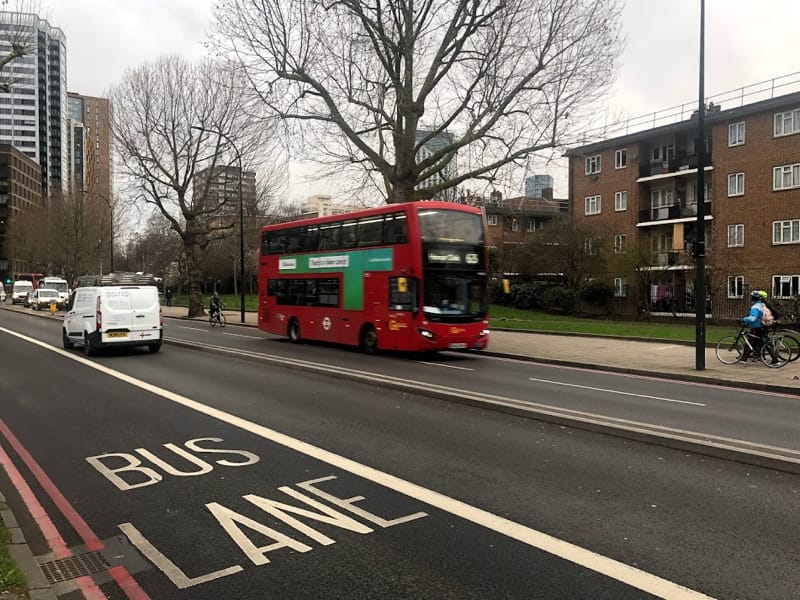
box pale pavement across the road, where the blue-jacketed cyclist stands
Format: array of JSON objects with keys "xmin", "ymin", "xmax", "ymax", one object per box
[{"xmin": 156, "ymin": 306, "xmax": 800, "ymax": 395}]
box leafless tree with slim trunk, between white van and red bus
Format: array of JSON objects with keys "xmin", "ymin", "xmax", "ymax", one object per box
[{"xmin": 109, "ymin": 56, "xmax": 265, "ymax": 316}]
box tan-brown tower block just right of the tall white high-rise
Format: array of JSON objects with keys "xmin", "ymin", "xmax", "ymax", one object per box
[{"xmin": 66, "ymin": 92, "xmax": 114, "ymax": 201}]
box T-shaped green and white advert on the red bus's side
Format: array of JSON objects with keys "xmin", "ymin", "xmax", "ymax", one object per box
[{"xmin": 278, "ymin": 248, "xmax": 394, "ymax": 310}]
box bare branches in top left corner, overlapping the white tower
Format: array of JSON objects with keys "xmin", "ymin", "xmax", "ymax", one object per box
[{"xmin": 0, "ymin": 0, "xmax": 41, "ymax": 93}]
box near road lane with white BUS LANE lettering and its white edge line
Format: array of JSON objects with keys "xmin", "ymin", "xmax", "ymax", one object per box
[{"xmin": 3, "ymin": 328, "xmax": 720, "ymax": 599}]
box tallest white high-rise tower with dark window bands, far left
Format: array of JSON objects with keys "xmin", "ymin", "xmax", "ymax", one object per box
[{"xmin": 0, "ymin": 11, "xmax": 67, "ymax": 190}]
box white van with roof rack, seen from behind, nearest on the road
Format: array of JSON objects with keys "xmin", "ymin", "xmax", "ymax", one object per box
[{"xmin": 62, "ymin": 285, "xmax": 163, "ymax": 356}]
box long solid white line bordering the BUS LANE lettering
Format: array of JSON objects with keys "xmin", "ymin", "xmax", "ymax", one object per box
[{"xmin": 0, "ymin": 327, "xmax": 713, "ymax": 600}]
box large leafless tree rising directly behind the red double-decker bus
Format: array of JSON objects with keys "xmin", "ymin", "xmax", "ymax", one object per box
[{"xmin": 212, "ymin": 0, "xmax": 622, "ymax": 202}]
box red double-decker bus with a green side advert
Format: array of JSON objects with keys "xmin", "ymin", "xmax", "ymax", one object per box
[{"xmin": 258, "ymin": 201, "xmax": 489, "ymax": 353}]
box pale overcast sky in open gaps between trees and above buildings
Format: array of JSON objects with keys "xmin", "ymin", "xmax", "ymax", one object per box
[{"xmin": 44, "ymin": 0, "xmax": 800, "ymax": 196}]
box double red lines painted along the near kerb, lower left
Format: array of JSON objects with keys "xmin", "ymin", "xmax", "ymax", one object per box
[{"xmin": 0, "ymin": 419, "xmax": 150, "ymax": 600}]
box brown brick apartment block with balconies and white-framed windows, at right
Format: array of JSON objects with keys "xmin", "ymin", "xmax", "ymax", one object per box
[{"xmin": 567, "ymin": 93, "xmax": 800, "ymax": 318}]
